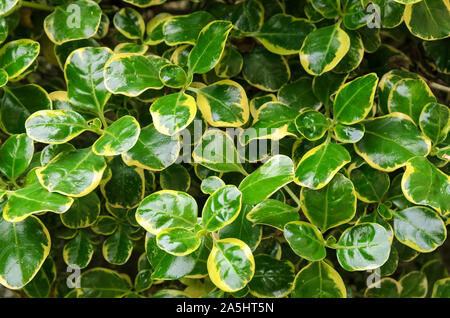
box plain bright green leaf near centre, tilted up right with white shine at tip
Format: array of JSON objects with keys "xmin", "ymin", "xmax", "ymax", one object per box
[{"xmin": 239, "ymin": 155, "xmax": 294, "ymax": 204}]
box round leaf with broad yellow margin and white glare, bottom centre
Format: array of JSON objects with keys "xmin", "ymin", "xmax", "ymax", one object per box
[{"xmin": 208, "ymin": 238, "xmax": 255, "ymax": 292}]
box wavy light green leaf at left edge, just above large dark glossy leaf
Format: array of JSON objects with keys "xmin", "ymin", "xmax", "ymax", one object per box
[{"xmin": 3, "ymin": 183, "xmax": 73, "ymax": 222}]
